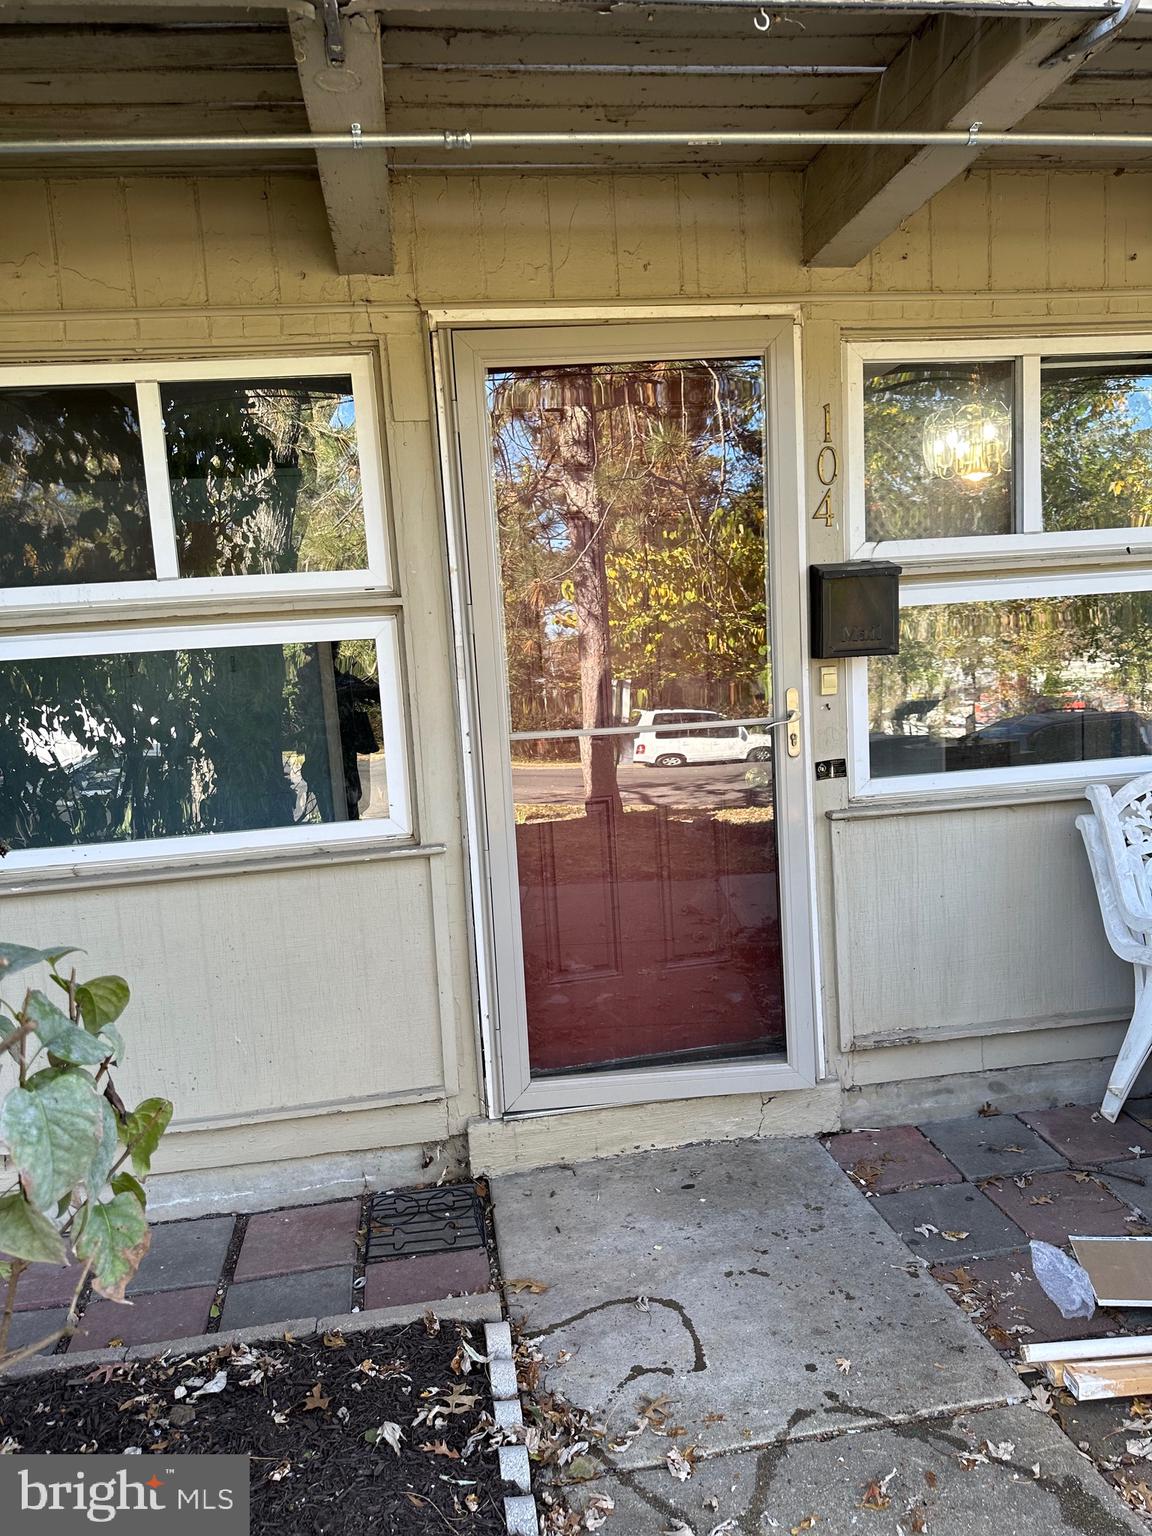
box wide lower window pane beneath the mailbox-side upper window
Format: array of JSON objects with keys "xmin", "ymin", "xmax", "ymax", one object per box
[{"xmin": 868, "ymin": 593, "xmax": 1152, "ymax": 777}]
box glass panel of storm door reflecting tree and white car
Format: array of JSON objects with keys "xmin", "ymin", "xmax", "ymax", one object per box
[{"xmin": 485, "ymin": 356, "xmax": 785, "ymax": 1077}]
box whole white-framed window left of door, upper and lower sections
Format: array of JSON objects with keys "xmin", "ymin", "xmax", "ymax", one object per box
[{"xmin": 0, "ymin": 358, "xmax": 412, "ymax": 869}]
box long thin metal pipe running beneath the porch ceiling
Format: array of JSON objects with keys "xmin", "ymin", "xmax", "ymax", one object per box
[{"xmin": 0, "ymin": 123, "xmax": 1152, "ymax": 160}]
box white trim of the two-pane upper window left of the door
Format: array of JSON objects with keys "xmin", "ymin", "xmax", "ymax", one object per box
[{"xmin": 0, "ymin": 352, "xmax": 395, "ymax": 616}]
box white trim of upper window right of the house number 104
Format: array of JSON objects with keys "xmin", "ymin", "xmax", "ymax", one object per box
[{"xmin": 845, "ymin": 332, "xmax": 1152, "ymax": 574}]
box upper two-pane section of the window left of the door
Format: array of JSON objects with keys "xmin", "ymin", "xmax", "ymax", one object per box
[{"xmin": 0, "ymin": 358, "xmax": 389, "ymax": 605}]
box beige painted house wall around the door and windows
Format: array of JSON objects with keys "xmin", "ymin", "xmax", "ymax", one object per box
[{"xmin": 0, "ymin": 172, "xmax": 1152, "ymax": 1167}]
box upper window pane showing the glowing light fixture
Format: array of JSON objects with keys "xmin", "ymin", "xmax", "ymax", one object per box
[{"xmin": 865, "ymin": 361, "xmax": 1015, "ymax": 539}]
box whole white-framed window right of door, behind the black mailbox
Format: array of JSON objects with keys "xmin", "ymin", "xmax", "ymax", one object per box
[{"xmin": 852, "ymin": 338, "xmax": 1152, "ymax": 794}]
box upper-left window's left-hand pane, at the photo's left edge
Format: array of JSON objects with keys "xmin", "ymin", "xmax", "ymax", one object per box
[{"xmin": 0, "ymin": 384, "xmax": 155, "ymax": 587}]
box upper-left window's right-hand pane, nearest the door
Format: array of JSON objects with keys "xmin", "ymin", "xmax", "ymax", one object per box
[{"xmin": 161, "ymin": 376, "xmax": 367, "ymax": 576}]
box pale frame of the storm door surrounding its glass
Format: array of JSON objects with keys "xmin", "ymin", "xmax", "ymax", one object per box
[{"xmin": 441, "ymin": 316, "xmax": 820, "ymax": 1115}]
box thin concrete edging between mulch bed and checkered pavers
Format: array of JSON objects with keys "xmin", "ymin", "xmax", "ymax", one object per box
[{"xmin": 0, "ymin": 1290, "xmax": 501, "ymax": 1381}]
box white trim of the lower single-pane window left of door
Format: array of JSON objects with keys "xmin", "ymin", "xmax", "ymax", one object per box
[{"xmin": 0, "ymin": 614, "xmax": 412, "ymax": 889}]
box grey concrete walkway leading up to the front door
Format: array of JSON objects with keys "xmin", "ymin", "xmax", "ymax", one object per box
[{"xmin": 493, "ymin": 1140, "xmax": 1143, "ymax": 1536}]
